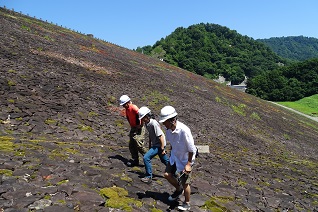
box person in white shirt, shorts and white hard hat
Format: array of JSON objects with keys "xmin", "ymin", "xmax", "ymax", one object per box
[{"xmin": 159, "ymin": 106, "xmax": 197, "ymax": 211}]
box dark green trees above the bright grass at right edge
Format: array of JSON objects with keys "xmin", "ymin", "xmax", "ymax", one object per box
[{"xmin": 247, "ymin": 58, "xmax": 318, "ymax": 101}]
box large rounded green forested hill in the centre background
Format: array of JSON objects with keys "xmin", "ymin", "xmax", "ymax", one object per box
[{"xmin": 136, "ymin": 23, "xmax": 286, "ymax": 84}]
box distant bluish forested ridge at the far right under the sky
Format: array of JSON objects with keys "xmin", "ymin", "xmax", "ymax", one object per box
[{"xmin": 257, "ymin": 36, "xmax": 318, "ymax": 61}]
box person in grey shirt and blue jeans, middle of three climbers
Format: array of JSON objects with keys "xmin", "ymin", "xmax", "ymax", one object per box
[{"xmin": 138, "ymin": 107, "xmax": 169, "ymax": 184}]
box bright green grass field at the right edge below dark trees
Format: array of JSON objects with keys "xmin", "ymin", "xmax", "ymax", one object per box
[{"xmin": 276, "ymin": 94, "xmax": 318, "ymax": 117}]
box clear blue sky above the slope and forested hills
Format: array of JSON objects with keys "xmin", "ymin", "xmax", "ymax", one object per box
[{"xmin": 0, "ymin": 0, "xmax": 318, "ymax": 49}]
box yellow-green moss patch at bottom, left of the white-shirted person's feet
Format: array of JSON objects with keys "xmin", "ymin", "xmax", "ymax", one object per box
[{"xmin": 100, "ymin": 187, "xmax": 142, "ymax": 211}]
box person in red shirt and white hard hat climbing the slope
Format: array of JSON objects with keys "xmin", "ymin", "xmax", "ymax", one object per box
[{"xmin": 119, "ymin": 95, "xmax": 146, "ymax": 166}]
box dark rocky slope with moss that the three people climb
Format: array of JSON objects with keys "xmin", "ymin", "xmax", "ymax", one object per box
[{"xmin": 0, "ymin": 8, "xmax": 318, "ymax": 211}]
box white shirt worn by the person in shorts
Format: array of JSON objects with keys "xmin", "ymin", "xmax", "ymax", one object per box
[{"xmin": 166, "ymin": 121, "xmax": 197, "ymax": 172}]
